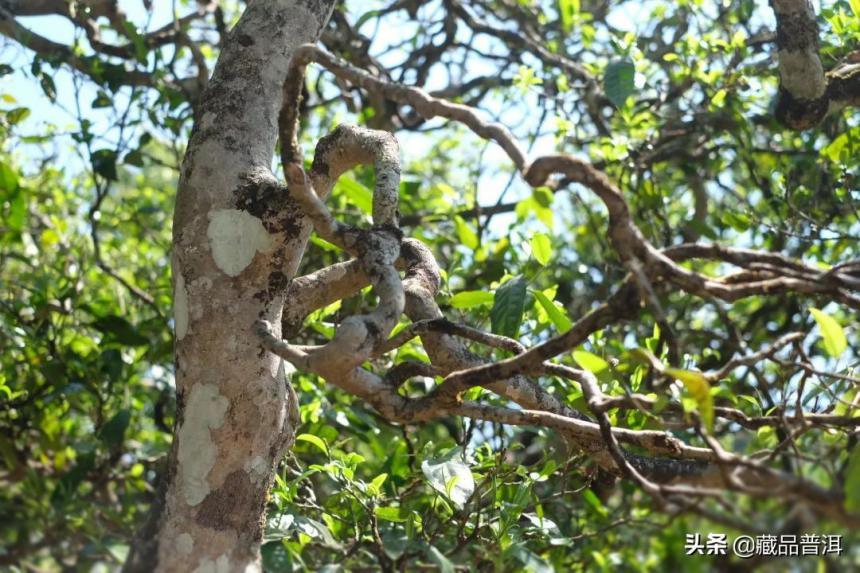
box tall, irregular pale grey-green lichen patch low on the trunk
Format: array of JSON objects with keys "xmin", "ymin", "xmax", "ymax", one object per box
[{"xmin": 177, "ymin": 384, "xmax": 230, "ymax": 506}]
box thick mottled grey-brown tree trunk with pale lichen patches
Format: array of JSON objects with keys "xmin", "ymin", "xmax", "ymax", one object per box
[{"xmin": 136, "ymin": 0, "xmax": 335, "ymax": 573}]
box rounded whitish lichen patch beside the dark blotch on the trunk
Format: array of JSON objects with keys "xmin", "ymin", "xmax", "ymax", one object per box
[{"xmin": 206, "ymin": 209, "xmax": 274, "ymax": 277}]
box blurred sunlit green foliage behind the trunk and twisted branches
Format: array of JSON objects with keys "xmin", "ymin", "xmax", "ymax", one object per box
[{"xmin": 0, "ymin": 0, "xmax": 860, "ymax": 571}]
